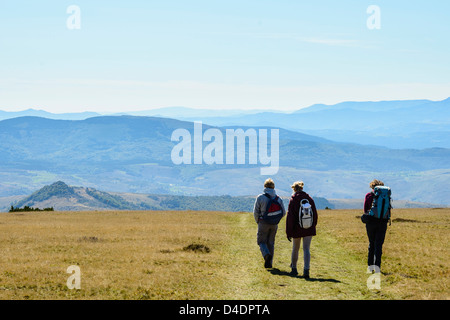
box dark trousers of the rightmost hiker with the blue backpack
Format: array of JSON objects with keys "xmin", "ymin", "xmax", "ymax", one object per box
[{"xmin": 366, "ymin": 221, "xmax": 387, "ymax": 268}]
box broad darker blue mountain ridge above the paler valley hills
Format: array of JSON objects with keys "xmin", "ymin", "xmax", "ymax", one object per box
[{"xmin": 0, "ymin": 116, "xmax": 450, "ymax": 172}]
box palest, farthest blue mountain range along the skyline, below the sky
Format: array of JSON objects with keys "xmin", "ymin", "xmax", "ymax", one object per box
[{"xmin": 0, "ymin": 98, "xmax": 450, "ymax": 149}]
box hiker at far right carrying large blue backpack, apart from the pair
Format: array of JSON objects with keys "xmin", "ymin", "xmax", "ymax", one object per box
[{"xmin": 361, "ymin": 180, "xmax": 392, "ymax": 272}]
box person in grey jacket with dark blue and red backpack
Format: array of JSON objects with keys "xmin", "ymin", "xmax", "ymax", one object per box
[{"xmin": 253, "ymin": 178, "xmax": 286, "ymax": 268}]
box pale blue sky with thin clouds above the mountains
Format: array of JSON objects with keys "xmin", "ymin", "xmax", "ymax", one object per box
[{"xmin": 0, "ymin": 0, "xmax": 450, "ymax": 113}]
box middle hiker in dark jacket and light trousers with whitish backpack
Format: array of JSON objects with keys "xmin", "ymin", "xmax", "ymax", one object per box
[{"xmin": 286, "ymin": 181, "xmax": 317, "ymax": 279}]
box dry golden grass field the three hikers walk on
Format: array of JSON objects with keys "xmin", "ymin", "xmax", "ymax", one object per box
[{"xmin": 0, "ymin": 209, "xmax": 450, "ymax": 300}]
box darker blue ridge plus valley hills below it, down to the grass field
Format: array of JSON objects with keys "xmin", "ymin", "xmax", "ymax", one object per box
[{"xmin": 0, "ymin": 115, "xmax": 450, "ymax": 205}]
